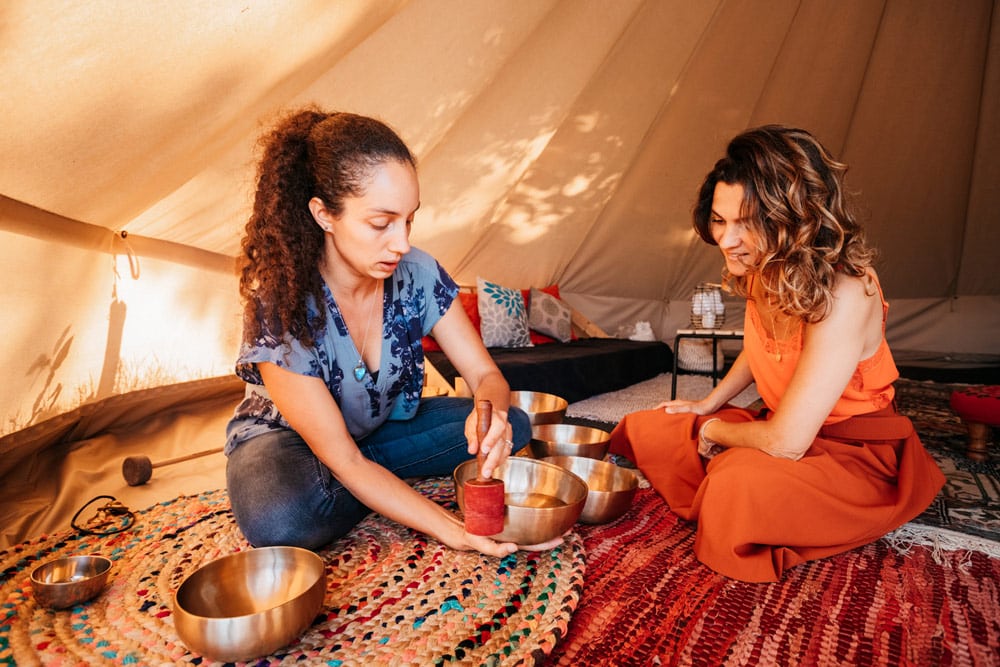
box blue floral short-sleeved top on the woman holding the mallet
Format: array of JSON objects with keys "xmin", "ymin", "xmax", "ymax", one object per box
[{"xmin": 225, "ymin": 248, "xmax": 458, "ymax": 454}]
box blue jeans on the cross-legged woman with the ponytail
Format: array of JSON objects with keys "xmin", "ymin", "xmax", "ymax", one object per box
[{"xmin": 226, "ymin": 397, "xmax": 531, "ymax": 549}]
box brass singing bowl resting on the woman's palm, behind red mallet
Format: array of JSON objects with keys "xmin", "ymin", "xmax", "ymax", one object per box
[{"xmin": 453, "ymin": 456, "xmax": 587, "ymax": 546}]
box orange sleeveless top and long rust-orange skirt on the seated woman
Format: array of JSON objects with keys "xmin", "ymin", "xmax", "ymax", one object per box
[{"xmin": 610, "ymin": 284, "xmax": 944, "ymax": 582}]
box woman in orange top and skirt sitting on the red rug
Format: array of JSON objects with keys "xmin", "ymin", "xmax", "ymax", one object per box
[{"xmin": 611, "ymin": 126, "xmax": 944, "ymax": 581}]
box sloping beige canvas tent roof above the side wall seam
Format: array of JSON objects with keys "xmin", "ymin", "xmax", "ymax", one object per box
[{"xmin": 0, "ymin": 0, "xmax": 1000, "ymax": 298}]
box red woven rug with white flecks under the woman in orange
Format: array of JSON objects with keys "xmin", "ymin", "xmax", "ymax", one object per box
[{"xmin": 544, "ymin": 489, "xmax": 1000, "ymax": 667}]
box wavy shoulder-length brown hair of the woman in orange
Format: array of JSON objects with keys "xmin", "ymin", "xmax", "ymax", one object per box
[{"xmin": 694, "ymin": 125, "xmax": 875, "ymax": 322}]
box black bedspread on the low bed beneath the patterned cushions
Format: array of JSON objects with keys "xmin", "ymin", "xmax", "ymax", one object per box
[{"xmin": 426, "ymin": 338, "xmax": 674, "ymax": 403}]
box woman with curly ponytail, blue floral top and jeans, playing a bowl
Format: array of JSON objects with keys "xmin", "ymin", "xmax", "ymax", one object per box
[{"xmin": 226, "ymin": 109, "xmax": 560, "ymax": 556}]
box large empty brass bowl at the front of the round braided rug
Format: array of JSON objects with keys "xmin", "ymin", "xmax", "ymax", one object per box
[{"xmin": 173, "ymin": 547, "xmax": 326, "ymax": 662}]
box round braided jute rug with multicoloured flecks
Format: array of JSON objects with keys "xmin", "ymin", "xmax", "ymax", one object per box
[{"xmin": 0, "ymin": 478, "xmax": 584, "ymax": 667}]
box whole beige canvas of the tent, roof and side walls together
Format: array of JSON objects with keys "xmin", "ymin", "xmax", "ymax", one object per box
[{"xmin": 0, "ymin": 0, "xmax": 1000, "ymax": 448}]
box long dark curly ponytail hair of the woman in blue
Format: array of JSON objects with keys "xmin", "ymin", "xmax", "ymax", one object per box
[{"xmin": 239, "ymin": 107, "xmax": 416, "ymax": 346}]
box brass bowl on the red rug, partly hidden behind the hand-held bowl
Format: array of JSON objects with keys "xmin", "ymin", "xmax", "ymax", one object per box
[{"xmin": 542, "ymin": 456, "xmax": 639, "ymax": 523}]
